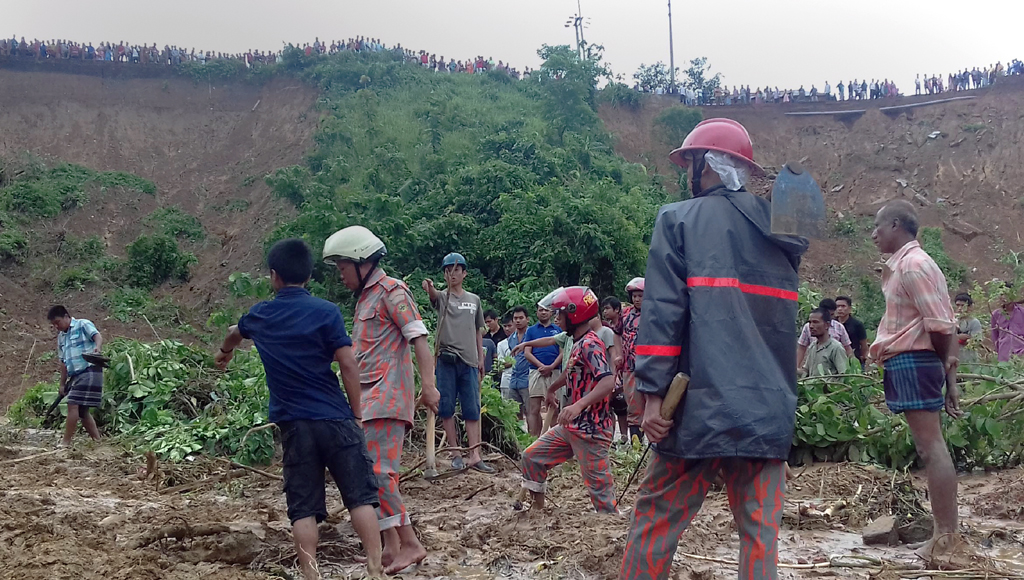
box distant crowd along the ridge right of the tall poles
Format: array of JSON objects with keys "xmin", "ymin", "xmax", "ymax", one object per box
[{"xmin": 651, "ymin": 58, "xmax": 1024, "ymax": 107}]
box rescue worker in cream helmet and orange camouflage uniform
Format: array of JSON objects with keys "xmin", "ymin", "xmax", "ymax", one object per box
[{"xmin": 324, "ymin": 225, "xmax": 440, "ymax": 574}]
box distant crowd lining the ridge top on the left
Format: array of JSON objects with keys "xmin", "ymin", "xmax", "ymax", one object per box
[{"xmin": 0, "ymin": 36, "xmax": 530, "ymax": 79}]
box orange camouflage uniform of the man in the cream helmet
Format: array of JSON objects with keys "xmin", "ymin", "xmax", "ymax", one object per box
[{"xmin": 352, "ymin": 268, "xmax": 427, "ymax": 530}]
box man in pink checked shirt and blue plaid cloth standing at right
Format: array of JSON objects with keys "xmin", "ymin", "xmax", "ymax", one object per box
[{"xmin": 870, "ymin": 200, "xmax": 963, "ymax": 562}]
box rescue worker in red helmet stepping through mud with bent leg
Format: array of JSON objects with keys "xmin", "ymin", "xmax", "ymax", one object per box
[{"xmin": 520, "ymin": 286, "xmax": 617, "ymax": 513}]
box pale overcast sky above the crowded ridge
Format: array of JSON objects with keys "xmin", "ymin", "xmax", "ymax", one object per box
[{"xmin": 8, "ymin": 0, "xmax": 1024, "ymax": 93}]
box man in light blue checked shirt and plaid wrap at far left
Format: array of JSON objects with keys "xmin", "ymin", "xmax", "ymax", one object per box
[{"xmin": 46, "ymin": 305, "xmax": 103, "ymax": 446}]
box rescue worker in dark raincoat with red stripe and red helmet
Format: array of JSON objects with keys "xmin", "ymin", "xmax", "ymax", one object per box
[{"xmin": 620, "ymin": 119, "xmax": 807, "ymax": 580}]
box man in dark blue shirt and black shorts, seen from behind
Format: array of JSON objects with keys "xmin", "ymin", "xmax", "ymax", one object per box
[{"xmin": 215, "ymin": 239, "xmax": 383, "ymax": 580}]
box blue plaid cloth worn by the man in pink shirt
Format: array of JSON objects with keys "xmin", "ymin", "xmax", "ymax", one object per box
[{"xmin": 882, "ymin": 350, "xmax": 946, "ymax": 413}]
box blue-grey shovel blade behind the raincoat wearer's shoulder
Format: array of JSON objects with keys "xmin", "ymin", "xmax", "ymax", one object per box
[{"xmin": 771, "ymin": 163, "xmax": 827, "ymax": 239}]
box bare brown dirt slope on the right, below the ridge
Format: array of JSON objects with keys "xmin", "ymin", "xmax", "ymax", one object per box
[{"xmin": 601, "ymin": 79, "xmax": 1024, "ymax": 287}]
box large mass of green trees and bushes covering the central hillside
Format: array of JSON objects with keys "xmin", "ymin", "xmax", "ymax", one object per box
[{"xmin": 266, "ymin": 47, "xmax": 669, "ymax": 303}]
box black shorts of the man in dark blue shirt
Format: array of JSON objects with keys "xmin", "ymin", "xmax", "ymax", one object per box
[{"xmin": 278, "ymin": 419, "xmax": 380, "ymax": 524}]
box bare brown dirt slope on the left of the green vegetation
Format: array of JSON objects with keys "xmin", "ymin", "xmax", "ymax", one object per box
[{"xmin": 0, "ymin": 68, "xmax": 317, "ymax": 407}]
